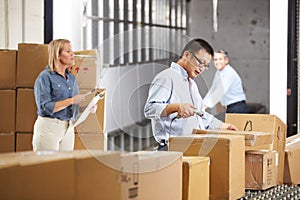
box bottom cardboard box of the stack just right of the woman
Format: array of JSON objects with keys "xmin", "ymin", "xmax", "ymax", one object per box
[{"xmin": 74, "ymin": 133, "xmax": 107, "ymax": 150}]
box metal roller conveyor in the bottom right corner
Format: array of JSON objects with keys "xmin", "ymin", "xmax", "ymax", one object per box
[{"xmin": 239, "ymin": 185, "xmax": 300, "ymax": 200}]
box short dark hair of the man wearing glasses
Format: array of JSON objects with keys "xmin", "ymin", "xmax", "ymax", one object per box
[{"xmin": 181, "ymin": 38, "xmax": 214, "ymax": 56}]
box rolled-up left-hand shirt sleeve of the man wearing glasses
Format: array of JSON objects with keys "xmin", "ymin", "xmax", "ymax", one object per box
[{"xmin": 144, "ymin": 78, "xmax": 172, "ymax": 119}]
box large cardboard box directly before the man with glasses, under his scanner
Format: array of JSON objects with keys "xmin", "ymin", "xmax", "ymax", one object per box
[{"xmin": 169, "ymin": 134, "xmax": 245, "ymax": 200}]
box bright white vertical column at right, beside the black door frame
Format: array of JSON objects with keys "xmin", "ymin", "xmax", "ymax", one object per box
[{"xmin": 270, "ymin": 0, "xmax": 288, "ymax": 123}]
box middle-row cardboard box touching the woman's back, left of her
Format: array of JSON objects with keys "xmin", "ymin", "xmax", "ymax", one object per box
[{"xmin": 16, "ymin": 88, "xmax": 37, "ymax": 133}]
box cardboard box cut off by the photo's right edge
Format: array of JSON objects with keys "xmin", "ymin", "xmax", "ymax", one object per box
[{"xmin": 284, "ymin": 134, "xmax": 300, "ymax": 185}]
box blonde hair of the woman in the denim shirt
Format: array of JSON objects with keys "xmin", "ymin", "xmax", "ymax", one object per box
[{"xmin": 48, "ymin": 39, "xmax": 71, "ymax": 72}]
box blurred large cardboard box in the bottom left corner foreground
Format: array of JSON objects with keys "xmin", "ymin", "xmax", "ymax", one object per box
[{"xmin": 0, "ymin": 152, "xmax": 76, "ymax": 200}]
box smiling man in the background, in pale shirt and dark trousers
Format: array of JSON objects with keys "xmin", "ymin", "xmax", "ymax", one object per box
[{"xmin": 203, "ymin": 50, "xmax": 248, "ymax": 113}]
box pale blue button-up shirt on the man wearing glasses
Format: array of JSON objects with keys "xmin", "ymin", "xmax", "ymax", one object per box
[{"xmin": 144, "ymin": 63, "xmax": 222, "ymax": 142}]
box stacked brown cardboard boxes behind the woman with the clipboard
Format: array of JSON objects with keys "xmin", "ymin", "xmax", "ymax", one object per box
[{"xmin": 0, "ymin": 43, "xmax": 105, "ymax": 152}]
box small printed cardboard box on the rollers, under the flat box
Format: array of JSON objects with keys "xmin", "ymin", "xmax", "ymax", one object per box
[{"xmin": 245, "ymin": 150, "xmax": 278, "ymax": 190}]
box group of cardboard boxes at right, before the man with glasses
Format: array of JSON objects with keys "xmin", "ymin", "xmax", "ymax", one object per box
[{"xmin": 169, "ymin": 114, "xmax": 286, "ymax": 199}]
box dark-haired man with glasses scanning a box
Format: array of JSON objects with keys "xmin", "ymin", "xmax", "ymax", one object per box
[{"xmin": 144, "ymin": 39, "xmax": 237, "ymax": 149}]
